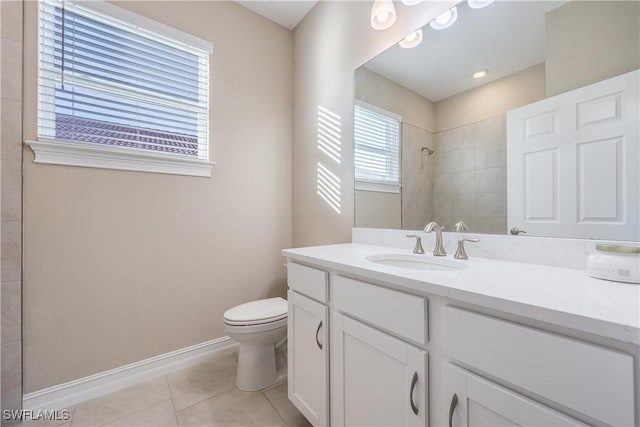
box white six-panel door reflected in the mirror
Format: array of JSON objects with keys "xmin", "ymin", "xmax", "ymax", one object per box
[{"xmin": 507, "ymin": 70, "xmax": 640, "ymax": 240}]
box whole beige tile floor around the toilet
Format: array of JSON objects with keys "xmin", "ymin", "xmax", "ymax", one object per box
[{"xmin": 17, "ymin": 353, "xmax": 310, "ymax": 427}]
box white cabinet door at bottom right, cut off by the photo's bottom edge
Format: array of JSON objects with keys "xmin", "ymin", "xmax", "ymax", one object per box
[{"xmin": 446, "ymin": 365, "xmax": 585, "ymax": 427}]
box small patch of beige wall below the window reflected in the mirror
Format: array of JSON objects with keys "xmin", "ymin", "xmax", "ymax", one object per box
[{"xmin": 355, "ymin": 190, "xmax": 402, "ymax": 229}]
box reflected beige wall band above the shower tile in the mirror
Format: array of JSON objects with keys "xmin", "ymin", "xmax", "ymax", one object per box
[{"xmin": 436, "ymin": 64, "xmax": 545, "ymax": 132}]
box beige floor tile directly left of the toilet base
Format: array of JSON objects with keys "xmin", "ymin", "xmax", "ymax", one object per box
[{"xmin": 167, "ymin": 353, "xmax": 238, "ymax": 411}]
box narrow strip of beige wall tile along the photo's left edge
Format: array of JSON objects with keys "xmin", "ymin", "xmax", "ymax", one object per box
[{"xmin": 0, "ymin": 0, "xmax": 23, "ymax": 426}]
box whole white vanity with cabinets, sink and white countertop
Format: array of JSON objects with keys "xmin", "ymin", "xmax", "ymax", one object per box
[{"xmin": 283, "ymin": 243, "xmax": 640, "ymax": 426}]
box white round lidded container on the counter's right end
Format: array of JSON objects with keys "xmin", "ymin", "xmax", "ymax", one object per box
[{"xmin": 587, "ymin": 245, "xmax": 640, "ymax": 283}]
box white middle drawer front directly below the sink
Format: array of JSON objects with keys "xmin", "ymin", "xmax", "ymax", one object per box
[{"xmin": 332, "ymin": 276, "xmax": 429, "ymax": 345}]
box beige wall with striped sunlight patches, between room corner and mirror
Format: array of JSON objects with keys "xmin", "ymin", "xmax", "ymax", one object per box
[{"xmin": 293, "ymin": 1, "xmax": 456, "ymax": 246}]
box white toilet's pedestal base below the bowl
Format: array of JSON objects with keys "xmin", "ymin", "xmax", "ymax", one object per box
[{"xmin": 236, "ymin": 343, "xmax": 277, "ymax": 391}]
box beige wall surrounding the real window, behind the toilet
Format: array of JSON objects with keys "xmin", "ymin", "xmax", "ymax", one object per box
[{"xmin": 24, "ymin": 1, "xmax": 293, "ymax": 392}]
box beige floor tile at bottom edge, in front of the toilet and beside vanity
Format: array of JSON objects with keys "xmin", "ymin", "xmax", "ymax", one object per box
[{"xmin": 177, "ymin": 389, "xmax": 285, "ymax": 427}]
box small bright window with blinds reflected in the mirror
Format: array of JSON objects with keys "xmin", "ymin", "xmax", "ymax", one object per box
[{"xmin": 354, "ymin": 102, "xmax": 402, "ymax": 192}]
